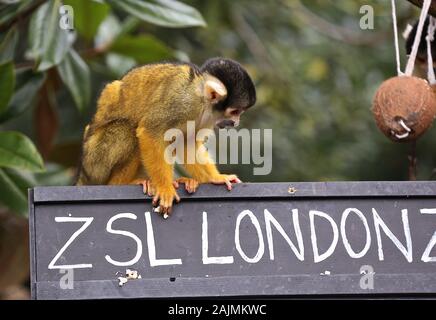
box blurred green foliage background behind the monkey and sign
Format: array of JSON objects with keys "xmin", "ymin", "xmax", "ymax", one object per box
[{"xmin": 0, "ymin": 0, "xmax": 436, "ymax": 213}]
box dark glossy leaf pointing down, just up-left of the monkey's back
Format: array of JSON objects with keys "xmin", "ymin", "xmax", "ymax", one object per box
[{"xmin": 58, "ymin": 50, "xmax": 91, "ymax": 111}]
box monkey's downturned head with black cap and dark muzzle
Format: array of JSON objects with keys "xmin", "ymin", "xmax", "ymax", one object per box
[{"xmin": 201, "ymin": 58, "xmax": 256, "ymax": 128}]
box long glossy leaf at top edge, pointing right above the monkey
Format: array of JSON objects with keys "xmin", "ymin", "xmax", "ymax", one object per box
[{"xmin": 106, "ymin": 0, "xmax": 206, "ymax": 28}]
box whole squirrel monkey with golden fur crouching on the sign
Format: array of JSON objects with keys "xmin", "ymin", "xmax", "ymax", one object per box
[{"xmin": 77, "ymin": 58, "xmax": 256, "ymax": 217}]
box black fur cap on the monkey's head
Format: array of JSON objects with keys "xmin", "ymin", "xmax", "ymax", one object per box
[{"xmin": 201, "ymin": 58, "xmax": 256, "ymax": 110}]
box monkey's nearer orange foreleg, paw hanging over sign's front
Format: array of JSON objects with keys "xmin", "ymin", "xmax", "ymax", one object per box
[{"xmin": 136, "ymin": 127, "xmax": 180, "ymax": 217}]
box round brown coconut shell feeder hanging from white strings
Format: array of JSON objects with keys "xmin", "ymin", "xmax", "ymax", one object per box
[{"xmin": 372, "ymin": 0, "xmax": 436, "ymax": 180}]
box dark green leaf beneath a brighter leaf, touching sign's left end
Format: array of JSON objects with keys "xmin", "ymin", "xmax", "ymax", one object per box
[{"xmin": 0, "ymin": 168, "xmax": 35, "ymax": 216}]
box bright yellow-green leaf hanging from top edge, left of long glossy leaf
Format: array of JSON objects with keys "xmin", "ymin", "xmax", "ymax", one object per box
[{"xmin": 63, "ymin": 0, "xmax": 110, "ymax": 40}]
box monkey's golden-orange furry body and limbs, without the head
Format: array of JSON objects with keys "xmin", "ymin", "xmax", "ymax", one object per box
[{"xmin": 77, "ymin": 64, "xmax": 235, "ymax": 212}]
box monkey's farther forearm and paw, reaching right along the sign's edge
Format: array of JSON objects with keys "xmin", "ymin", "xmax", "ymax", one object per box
[{"xmin": 184, "ymin": 141, "xmax": 241, "ymax": 190}]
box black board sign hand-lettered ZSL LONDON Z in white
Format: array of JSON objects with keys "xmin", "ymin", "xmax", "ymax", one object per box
[{"xmin": 29, "ymin": 182, "xmax": 436, "ymax": 299}]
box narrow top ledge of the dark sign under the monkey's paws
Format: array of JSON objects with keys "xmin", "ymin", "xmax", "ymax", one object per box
[{"xmin": 29, "ymin": 181, "xmax": 436, "ymax": 203}]
